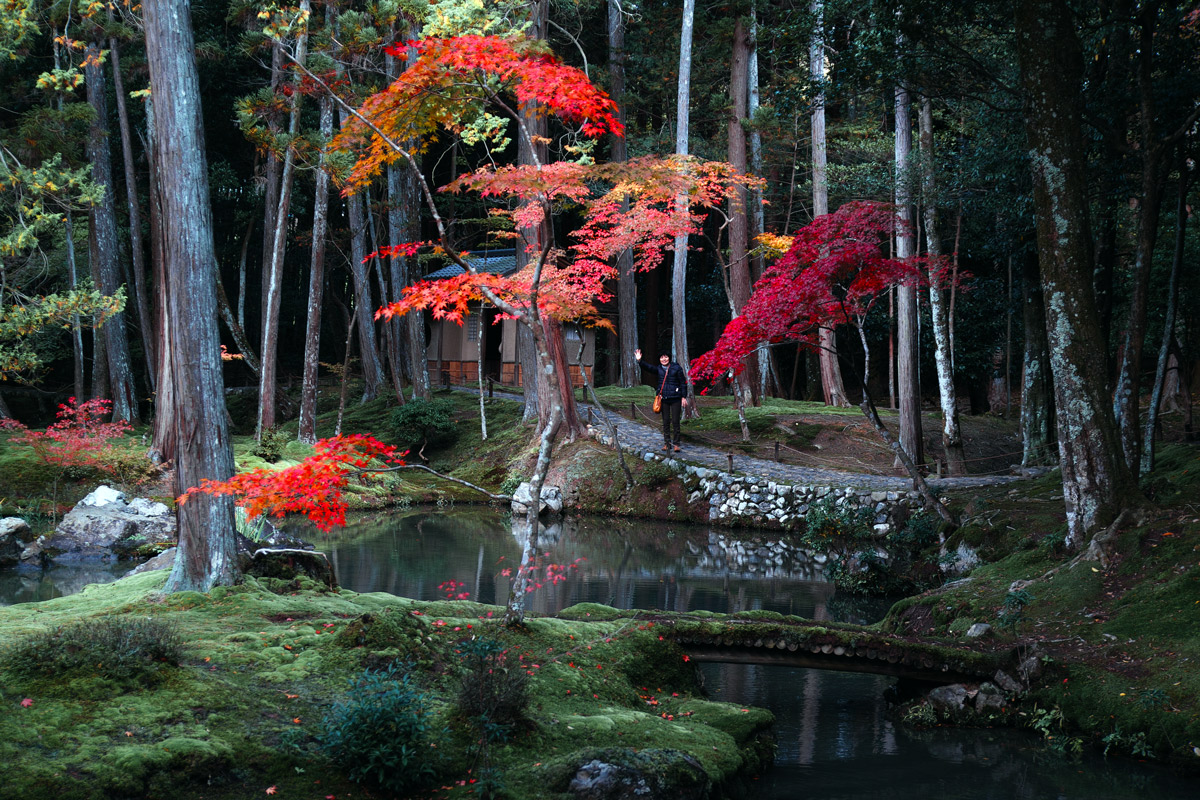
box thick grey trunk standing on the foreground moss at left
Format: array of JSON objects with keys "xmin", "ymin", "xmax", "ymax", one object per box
[{"xmin": 143, "ymin": 0, "xmax": 238, "ymax": 591}]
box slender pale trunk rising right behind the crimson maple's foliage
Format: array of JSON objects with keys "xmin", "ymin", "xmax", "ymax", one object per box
[{"xmin": 895, "ymin": 77, "xmax": 925, "ymax": 467}]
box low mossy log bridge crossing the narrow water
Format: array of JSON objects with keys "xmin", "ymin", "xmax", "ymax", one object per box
[{"xmin": 655, "ymin": 612, "xmax": 1015, "ymax": 684}]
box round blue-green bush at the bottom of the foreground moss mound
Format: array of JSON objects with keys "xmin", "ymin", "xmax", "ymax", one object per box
[{"xmin": 319, "ymin": 664, "xmax": 443, "ymax": 796}]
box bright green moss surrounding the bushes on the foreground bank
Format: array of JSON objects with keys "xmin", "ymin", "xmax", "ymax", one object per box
[{"xmin": 0, "ymin": 572, "xmax": 772, "ymax": 800}]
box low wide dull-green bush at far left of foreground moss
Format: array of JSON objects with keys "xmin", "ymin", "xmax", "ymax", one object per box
[{"xmin": 0, "ymin": 616, "xmax": 184, "ymax": 691}]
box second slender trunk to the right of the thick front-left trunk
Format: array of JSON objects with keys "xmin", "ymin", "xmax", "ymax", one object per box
[{"xmin": 296, "ymin": 95, "xmax": 334, "ymax": 444}]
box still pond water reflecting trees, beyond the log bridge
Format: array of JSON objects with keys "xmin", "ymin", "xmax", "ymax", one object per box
[{"xmin": 317, "ymin": 507, "xmax": 833, "ymax": 618}]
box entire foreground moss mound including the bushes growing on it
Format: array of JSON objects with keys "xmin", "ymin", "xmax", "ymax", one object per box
[{"xmin": 0, "ymin": 572, "xmax": 773, "ymax": 800}]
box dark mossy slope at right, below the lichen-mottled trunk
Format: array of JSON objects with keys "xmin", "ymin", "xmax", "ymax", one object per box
[{"xmin": 882, "ymin": 445, "xmax": 1200, "ymax": 769}]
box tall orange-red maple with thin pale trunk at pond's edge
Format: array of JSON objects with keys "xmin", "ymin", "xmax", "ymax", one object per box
[{"xmin": 276, "ymin": 36, "xmax": 749, "ymax": 622}]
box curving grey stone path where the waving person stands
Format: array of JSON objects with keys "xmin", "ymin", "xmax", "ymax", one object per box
[{"xmin": 458, "ymin": 391, "xmax": 1021, "ymax": 492}]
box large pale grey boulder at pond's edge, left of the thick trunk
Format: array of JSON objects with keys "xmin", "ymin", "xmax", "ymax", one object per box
[{"xmin": 38, "ymin": 486, "xmax": 175, "ymax": 564}]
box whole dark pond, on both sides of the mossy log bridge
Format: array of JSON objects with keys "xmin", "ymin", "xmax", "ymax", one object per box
[{"xmin": 0, "ymin": 507, "xmax": 1195, "ymax": 800}]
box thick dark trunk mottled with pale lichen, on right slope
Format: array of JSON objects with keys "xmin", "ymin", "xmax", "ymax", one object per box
[{"xmin": 1014, "ymin": 0, "xmax": 1141, "ymax": 548}]
